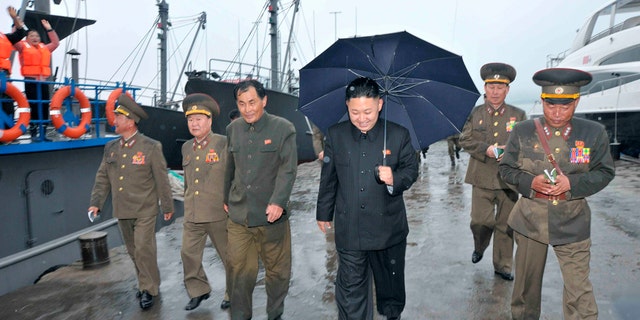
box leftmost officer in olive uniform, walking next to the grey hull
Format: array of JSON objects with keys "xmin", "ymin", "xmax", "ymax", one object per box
[{"xmin": 89, "ymin": 94, "xmax": 173, "ymax": 309}]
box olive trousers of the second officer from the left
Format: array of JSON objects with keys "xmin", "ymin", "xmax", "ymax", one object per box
[{"xmin": 180, "ymin": 220, "xmax": 231, "ymax": 301}]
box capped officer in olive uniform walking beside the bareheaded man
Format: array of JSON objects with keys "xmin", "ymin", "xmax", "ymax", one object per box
[{"xmin": 180, "ymin": 93, "xmax": 231, "ymax": 310}]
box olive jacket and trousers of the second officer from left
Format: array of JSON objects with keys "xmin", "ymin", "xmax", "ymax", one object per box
[{"xmin": 180, "ymin": 132, "xmax": 230, "ymax": 300}]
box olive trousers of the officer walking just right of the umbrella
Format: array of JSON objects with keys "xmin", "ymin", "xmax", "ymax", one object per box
[{"xmin": 470, "ymin": 186, "xmax": 518, "ymax": 273}]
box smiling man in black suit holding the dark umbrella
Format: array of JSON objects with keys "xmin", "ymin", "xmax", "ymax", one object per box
[{"xmin": 316, "ymin": 78, "xmax": 418, "ymax": 319}]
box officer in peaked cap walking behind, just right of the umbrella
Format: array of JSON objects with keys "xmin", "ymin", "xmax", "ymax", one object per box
[{"xmin": 460, "ymin": 63, "xmax": 525, "ymax": 281}]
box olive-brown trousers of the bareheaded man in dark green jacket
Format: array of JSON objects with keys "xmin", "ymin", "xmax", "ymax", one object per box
[{"xmin": 227, "ymin": 218, "xmax": 291, "ymax": 320}]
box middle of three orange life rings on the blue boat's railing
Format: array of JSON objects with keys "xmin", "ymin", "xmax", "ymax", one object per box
[{"xmin": 49, "ymin": 86, "xmax": 91, "ymax": 139}]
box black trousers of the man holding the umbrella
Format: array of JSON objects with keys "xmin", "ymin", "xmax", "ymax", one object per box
[{"xmin": 336, "ymin": 239, "xmax": 407, "ymax": 320}]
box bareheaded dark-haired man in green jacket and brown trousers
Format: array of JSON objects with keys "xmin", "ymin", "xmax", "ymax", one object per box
[{"xmin": 224, "ymin": 80, "xmax": 298, "ymax": 320}]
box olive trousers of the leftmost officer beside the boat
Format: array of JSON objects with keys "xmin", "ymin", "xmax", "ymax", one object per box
[{"xmin": 118, "ymin": 216, "xmax": 160, "ymax": 296}]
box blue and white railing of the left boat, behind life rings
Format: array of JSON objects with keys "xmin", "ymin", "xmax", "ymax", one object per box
[{"xmin": 0, "ymin": 75, "xmax": 139, "ymax": 154}]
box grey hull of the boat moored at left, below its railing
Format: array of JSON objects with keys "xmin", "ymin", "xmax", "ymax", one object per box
[{"xmin": 0, "ymin": 141, "xmax": 184, "ymax": 295}]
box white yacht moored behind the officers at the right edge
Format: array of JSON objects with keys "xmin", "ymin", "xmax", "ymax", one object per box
[{"xmin": 531, "ymin": 0, "xmax": 640, "ymax": 157}]
